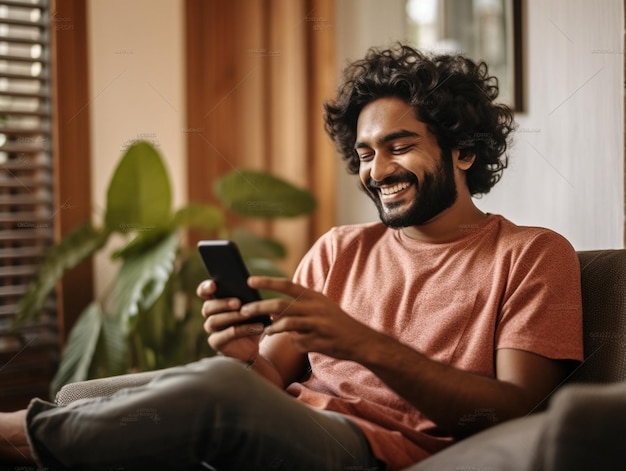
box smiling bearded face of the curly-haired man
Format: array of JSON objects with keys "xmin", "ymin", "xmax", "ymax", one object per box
[{"xmin": 355, "ymin": 98, "xmax": 457, "ymax": 228}]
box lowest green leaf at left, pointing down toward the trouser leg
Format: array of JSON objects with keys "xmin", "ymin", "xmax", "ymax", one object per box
[{"xmin": 50, "ymin": 302, "xmax": 104, "ymax": 397}]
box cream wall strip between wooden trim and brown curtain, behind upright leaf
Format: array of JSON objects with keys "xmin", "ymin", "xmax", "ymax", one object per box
[{"xmin": 87, "ymin": 0, "xmax": 186, "ymax": 295}]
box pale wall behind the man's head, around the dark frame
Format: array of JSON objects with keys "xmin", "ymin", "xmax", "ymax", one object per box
[{"xmin": 336, "ymin": 0, "xmax": 624, "ymax": 250}]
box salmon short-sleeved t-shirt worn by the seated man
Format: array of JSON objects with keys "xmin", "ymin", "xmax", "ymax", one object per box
[{"xmin": 287, "ymin": 215, "xmax": 583, "ymax": 470}]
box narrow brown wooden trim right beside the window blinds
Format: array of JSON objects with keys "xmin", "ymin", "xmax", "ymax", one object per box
[{"xmin": 50, "ymin": 0, "xmax": 93, "ymax": 345}]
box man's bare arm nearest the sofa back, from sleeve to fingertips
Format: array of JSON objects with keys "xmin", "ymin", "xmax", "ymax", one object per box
[{"xmin": 242, "ymin": 277, "xmax": 567, "ymax": 436}]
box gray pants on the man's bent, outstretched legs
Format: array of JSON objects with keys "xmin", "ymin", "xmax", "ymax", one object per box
[{"xmin": 27, "ymin": 357, "xmax": 379, "ymax": 471}]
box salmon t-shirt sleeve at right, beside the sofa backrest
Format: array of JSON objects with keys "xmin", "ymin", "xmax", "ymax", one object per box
[{"xmin": 496, "ymin": 231, "xmax": 583, "ymax": 360}]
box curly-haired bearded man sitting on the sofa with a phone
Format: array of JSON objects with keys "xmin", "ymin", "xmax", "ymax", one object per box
[{"xmin": 0, "ymin": 46, "xmax": 582, "ymax": 471}]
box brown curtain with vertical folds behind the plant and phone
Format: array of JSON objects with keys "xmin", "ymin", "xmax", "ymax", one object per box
[{"xmin": 185, "ymin": 0, "xmax": 336, "ymax": 273}]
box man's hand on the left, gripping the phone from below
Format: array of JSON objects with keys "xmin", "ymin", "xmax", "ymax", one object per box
[{"xmin": 196, "ymin": 280, "xmax": 263, "ymax": 362}]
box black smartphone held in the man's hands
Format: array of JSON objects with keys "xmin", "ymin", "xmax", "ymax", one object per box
[{"xmin": 198, "ymin": 240, "xmax": 272, "ymax": 326}]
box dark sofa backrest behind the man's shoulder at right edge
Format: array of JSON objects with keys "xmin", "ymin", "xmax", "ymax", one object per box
[{"xmin": 569, "ymin": 250, "xmax": 626, "ymax": 383}]
